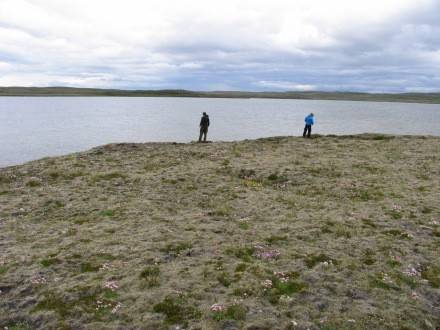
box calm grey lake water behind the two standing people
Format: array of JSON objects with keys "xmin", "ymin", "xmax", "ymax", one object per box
[{"xmin": 0, "ymin": 97, "xmax": 440, "ymax": 167}]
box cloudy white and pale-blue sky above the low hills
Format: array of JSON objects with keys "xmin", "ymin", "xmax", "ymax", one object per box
[{"xmin": 0, "ymin": 0, "xmax": 440, "ymax": 93}]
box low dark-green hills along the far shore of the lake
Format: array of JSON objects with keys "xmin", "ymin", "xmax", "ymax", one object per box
[{"xmin": 0, "ymin": 87, "xmax": 440, "ymax": 104}]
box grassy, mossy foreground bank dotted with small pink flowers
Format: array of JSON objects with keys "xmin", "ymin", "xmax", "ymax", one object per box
[{"xmin": 0, "ymin": 134, "xmax": 440, "ymax": 329}]
